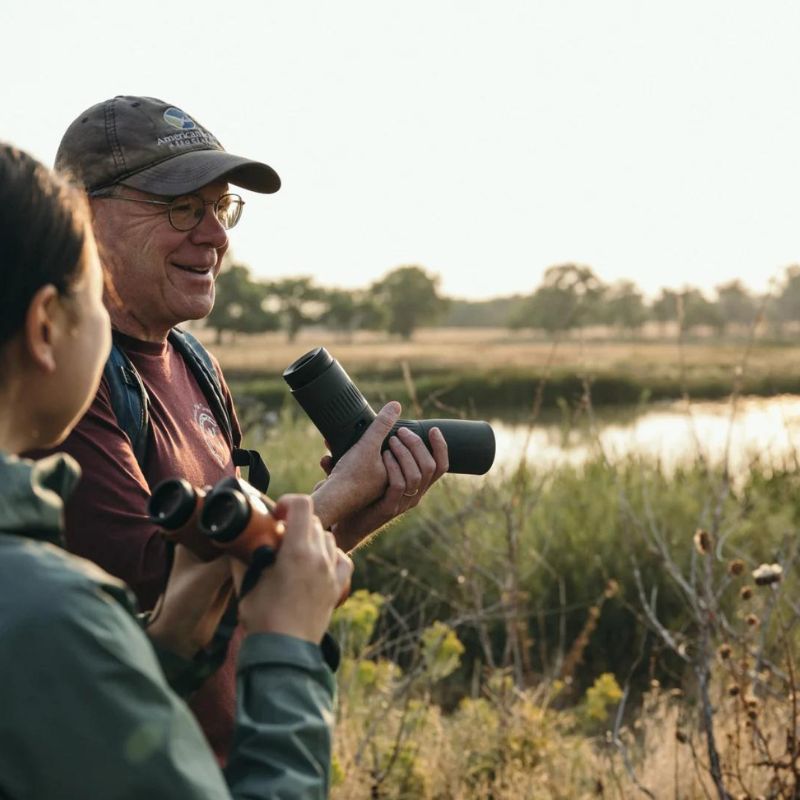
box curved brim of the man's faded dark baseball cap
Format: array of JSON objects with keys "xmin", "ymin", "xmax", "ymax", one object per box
[{"xmin": 121, "ymin": 150, "xmax": 281, "ymax": 196}]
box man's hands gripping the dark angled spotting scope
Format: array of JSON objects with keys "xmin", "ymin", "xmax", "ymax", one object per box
[{"xmin": 312, "ymin": 402, "xmax": 448, "ymax": 550}]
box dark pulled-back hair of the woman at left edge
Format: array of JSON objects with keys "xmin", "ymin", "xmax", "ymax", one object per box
[{"xmin": 0, "ymin": 142, "xmax": 89, "ymax": 346}]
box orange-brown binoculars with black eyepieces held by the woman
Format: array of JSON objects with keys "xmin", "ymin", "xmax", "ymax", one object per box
[{"xmin": 147, "ymin": 477, "xmax": 284, "ymax": 563}]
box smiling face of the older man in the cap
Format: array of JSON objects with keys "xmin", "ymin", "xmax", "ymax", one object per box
[{"xmin": 92, "ymin": 182, "xmax": 233, "ymax": 341}]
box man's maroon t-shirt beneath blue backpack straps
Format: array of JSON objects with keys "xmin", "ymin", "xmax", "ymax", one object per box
[{"xmin": 32, "ymin": 334, "xmax": 241, "ymax": 763}]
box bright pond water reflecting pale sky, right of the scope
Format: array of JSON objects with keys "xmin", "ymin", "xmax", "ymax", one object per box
[{"xmin": 492, "ymin": 395, "xmax": 800, "ymax": 475}]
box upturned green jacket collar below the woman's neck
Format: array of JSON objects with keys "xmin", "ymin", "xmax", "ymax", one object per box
[{"xmin": 0, "ymin": 452, "xmax": 80, "ymax": 544}]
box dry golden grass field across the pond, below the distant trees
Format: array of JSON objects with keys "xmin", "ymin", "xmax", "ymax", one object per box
[{"xmin": 192, "ymin": 328, "xmax": 800, "ymax": 414}]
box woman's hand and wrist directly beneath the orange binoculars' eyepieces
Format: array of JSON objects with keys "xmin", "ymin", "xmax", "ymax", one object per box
[{"xmin": 147, "ymin": 544, "xmax": 233, "ymax": 658}]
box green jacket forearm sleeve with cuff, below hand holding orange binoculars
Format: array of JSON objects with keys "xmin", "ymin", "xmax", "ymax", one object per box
[{"xmin": 225, "ymin": 634, "xmax": 334, "ymax": 800}]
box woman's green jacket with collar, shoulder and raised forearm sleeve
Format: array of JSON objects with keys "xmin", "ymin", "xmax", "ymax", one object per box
[{"xmin": 0, "ymin": 453, "xmax": 334, "ymax": 800}]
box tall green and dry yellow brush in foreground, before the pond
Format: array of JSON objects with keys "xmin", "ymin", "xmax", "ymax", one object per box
[{"xmin": 260, "ymin": 414, "xmax": 800, "ymax": 800}]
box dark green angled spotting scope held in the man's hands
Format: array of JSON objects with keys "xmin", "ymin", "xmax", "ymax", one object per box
[{"xmin": 283, "ymin": 347, "xmax": 495, "ymax": 475}]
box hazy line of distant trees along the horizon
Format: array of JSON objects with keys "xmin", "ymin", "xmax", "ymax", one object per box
[{"xmin": 207, "ymin": 261, "xmax": 800, "ymax": 341}]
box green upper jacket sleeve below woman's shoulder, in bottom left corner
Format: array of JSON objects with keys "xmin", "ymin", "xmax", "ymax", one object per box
[{"xmin": 0, "ymin": 582, "xmax": 231, "ymax": 800}]
